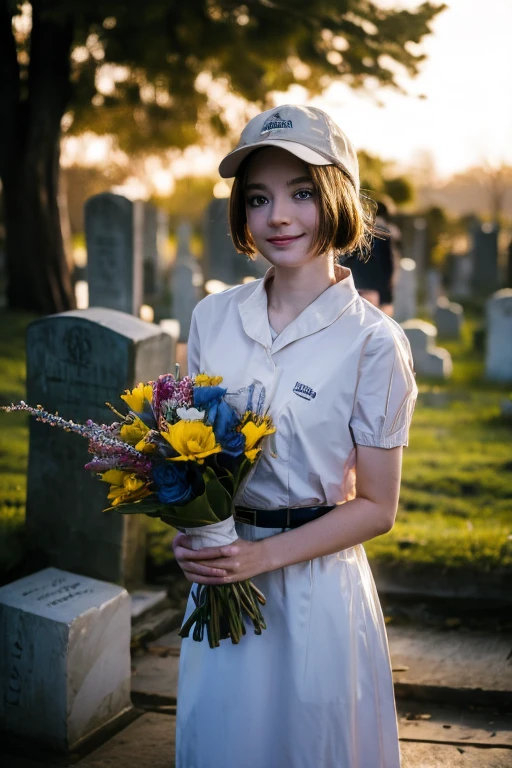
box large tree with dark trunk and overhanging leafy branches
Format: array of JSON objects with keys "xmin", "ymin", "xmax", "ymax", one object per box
[{"xmin": 0, "ymin": 0, "xmax": 444, "ymax": 313}]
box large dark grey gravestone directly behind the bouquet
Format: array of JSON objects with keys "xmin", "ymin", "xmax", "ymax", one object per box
[{"xmin": 26, "ymin": 308, "xmax": 174, "ymax": 588}]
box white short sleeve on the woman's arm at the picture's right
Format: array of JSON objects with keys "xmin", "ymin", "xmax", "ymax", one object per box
[{"xmin": 350, "ymin": 326, "xmax": 418, "ymax": 448}]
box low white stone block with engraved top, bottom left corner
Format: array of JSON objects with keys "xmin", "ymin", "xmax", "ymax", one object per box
[{"xmin": 0, "ymin": 568, "xmax": 131, "ymax": 752}]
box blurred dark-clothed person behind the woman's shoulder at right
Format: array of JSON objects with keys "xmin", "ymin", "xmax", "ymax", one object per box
[{"xmin": 343, "ymin": 200, "xmax": 401, "ymax": 317}]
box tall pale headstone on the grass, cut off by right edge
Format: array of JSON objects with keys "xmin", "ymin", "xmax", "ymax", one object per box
[{"xmin": 485, "ymin": 288, "xmax": 512, "ymax": 382}]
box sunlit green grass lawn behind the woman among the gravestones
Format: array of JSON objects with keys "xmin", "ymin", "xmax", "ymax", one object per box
[{"xmin": 0, "ymin": 311, "xmax": 512, "ymax": 573}]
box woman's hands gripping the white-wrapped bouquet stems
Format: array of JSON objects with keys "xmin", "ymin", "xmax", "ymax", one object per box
[{"xmin": 174, "ymin": 534, "xmax": 266, "ymax": 586}]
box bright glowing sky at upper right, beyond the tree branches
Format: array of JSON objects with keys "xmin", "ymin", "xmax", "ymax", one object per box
[{"xmin": 306, "ymin": 0, "xmax": 512, "ymax": 178}]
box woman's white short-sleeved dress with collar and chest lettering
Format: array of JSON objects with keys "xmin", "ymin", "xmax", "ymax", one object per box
[{"xmin": 176, "ymin": 268, "xmax": 417, "ymax": 768}]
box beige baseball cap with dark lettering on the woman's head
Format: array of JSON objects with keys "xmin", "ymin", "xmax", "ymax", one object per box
[{"xmin": 219, "ymin": 104, "xmax": 359, "ymax": 193}]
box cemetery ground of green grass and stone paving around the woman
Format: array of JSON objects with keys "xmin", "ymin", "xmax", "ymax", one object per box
[{"xmin": 0, "ymin": 311, "xmax": 512, "ymax": 768}]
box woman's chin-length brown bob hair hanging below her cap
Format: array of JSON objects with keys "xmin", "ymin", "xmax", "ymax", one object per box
[{"xmin": 229, "ymin": 150, "xmax": 376, "ymax": 259}]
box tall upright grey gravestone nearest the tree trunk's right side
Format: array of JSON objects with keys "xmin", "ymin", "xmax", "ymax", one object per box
[{"xmin": 85, "ymin": 192, "xmax": 144, "ymax": 317}]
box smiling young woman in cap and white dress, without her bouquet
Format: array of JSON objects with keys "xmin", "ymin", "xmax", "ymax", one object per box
[{"xmin": 174, "ymin": 105, "xmax": 417, "ymax": 768}]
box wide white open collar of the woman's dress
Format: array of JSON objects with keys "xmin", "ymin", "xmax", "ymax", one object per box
[{"xmin": 238, "ymin": 265, "xmax": 359, "ymax": 352}]
